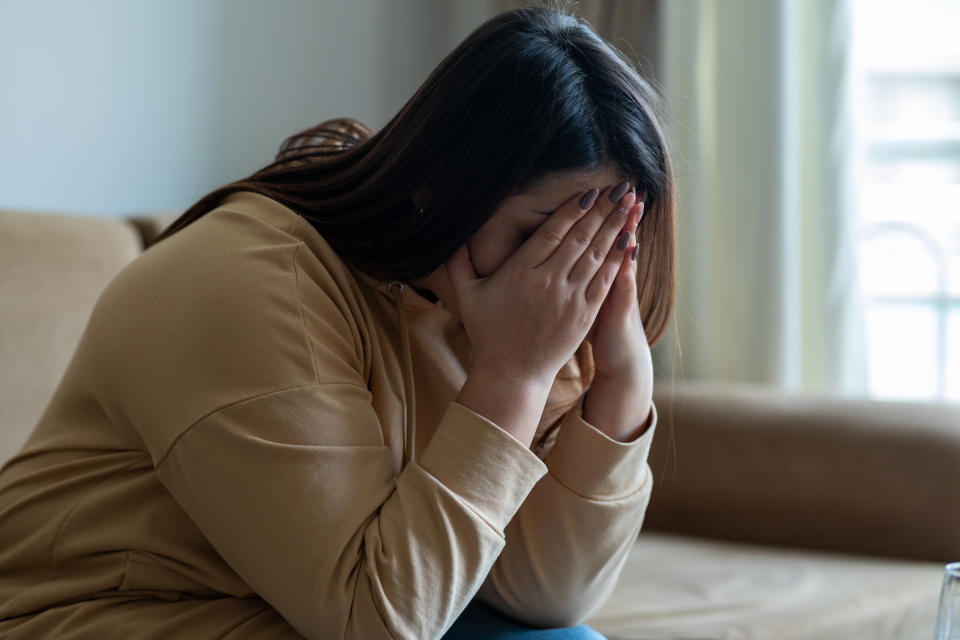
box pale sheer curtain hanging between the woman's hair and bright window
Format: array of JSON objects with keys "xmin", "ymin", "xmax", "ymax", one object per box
[{"xmin": 655, "ymin": 0, "xmax": 867, "ymax": 394}]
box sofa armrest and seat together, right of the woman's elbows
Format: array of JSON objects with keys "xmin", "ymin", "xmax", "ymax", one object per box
[{"xmin": 589, "ymin": 382, "xmax": 960, "ymax": 640}]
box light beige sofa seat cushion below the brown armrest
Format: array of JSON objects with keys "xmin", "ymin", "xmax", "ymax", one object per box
[{"xmin": 587, "ymin": 531, "xmax": 943, "ymax": 640}]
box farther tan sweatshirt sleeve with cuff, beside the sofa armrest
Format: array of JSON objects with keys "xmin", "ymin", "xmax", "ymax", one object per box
[{"xmin": 478, "ymin": 394, "xmax": 657, "ymax": 627}]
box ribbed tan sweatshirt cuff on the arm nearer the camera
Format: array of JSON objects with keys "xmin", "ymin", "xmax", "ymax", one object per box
[{"xmin": 417, "ymin": 401, "xmax": 547, "ymax": 536}]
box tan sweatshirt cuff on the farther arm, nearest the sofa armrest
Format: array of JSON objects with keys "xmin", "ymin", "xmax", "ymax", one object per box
[{"xmin": 545, "ymin": 393, "xmax": 657, "ymax": 500}]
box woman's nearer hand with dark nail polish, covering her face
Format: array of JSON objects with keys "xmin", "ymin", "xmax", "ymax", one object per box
[{"xmin": 446, "ymin": 183, "xmax": 636, "ymax": 388}]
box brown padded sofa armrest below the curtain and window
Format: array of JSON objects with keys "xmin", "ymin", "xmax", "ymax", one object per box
[{"xmin": 645, "ymin": 383, "xmax": 960, "ymax": 562}]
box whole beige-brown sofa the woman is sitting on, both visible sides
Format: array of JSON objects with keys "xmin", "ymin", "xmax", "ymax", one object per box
[{"xmin": 0, "ymin": 205, "xmax": 960, "ymax": 640}]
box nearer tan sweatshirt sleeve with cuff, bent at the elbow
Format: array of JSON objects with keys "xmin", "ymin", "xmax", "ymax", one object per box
[{"xmin": 157, "ymin": 382, "xmax": 546, "ymax": 640}]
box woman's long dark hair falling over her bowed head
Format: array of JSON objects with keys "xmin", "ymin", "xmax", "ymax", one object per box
[{"xmin": 157, "ymin": 6, "xmax": 677, "ymax": 344}]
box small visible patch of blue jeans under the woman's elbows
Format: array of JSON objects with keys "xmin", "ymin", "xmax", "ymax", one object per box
[{"xmin": 443, "ymin": 598, "xmax": 606, "ymax": 640}]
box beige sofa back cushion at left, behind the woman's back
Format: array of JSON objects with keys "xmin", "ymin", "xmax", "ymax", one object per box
[{"xmin": 0, "ymin": 210, "xmax": 141, "ymax": 465}]
